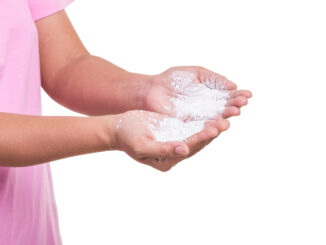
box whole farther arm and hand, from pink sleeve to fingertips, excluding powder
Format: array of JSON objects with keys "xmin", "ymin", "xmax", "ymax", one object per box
[{"xmin": 36, "ymin": 11, "xmax": 251, "ymax": 118}]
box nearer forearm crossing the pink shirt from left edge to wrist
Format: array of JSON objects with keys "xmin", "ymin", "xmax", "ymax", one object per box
[{"xmin": 0, "ymin": 113, "xmax": 115, "ymax": 167}]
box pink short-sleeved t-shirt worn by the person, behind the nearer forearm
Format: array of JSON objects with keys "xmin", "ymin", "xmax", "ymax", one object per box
[{"xmin": 0, "ymin": 0, "xmax": 71, "ymax": 245}]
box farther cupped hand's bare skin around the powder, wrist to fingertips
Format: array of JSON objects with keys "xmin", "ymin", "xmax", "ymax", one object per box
[{"xmin": 145, "ymin": 66, "xmax": 251, "ymax": 118}]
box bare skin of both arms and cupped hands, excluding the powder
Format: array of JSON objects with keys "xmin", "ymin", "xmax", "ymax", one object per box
[{"xmin": 0, "ymin": 11, "xmax": 251, "ymax": 171}]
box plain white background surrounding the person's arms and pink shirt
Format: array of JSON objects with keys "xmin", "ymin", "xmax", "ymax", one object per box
[{"xmin": 43, "ymin": 0, "xmax": 326, "ymax": 245}]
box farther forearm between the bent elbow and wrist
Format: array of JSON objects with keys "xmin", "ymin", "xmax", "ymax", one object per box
[{"xmin": 43, "ymin": 54, "xmax": 150, "ymax": 115}]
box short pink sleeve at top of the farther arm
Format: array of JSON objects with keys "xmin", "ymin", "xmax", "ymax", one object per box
[{"xmin": 29, "ymin": 0, "xmax": 73, "ymax": 20}]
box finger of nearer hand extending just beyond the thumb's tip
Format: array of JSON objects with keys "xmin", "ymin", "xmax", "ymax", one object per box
[{"xmin": 185, "ymin": 127, "xmax": 220, "ymax": 153}]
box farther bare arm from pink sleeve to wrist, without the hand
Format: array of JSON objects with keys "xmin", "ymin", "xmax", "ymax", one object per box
[{"xmin": 37, "ymin": 11, "xmax": 149, "ymax": 115}]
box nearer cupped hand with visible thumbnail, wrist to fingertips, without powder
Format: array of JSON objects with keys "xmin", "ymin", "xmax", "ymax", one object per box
[{"xmin": 111, "ymin": 110, "xmax": 229, "ymax": 171}]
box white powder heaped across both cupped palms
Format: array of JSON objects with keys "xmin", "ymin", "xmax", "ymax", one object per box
[{"xmin": 148, "ymin": 71, "xmax": 229, "ymax": 142}]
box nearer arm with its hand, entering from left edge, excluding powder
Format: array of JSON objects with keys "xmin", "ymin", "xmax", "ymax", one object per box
[{"xmin": 0, "ymin": 111, "xmax": 194, "ymax": 171}]
